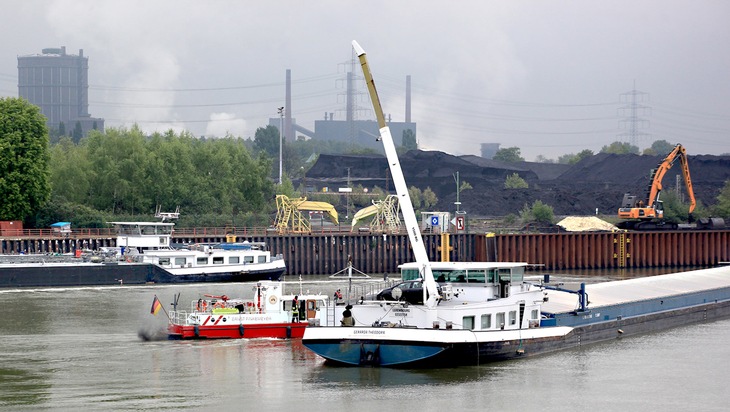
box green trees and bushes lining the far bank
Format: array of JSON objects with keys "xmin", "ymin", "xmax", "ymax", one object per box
[{"xmin": 0, "ymin": 98, "xmax": 730, "ymax": 228}]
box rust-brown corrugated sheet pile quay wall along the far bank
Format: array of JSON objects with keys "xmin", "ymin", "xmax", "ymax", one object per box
[{"xmin": 0, "ymin": 230, "xmax": 730, "ymax": 275}]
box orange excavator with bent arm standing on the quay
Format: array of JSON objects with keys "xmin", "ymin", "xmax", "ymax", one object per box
[{"xmin": 618, "ymin": 144, "xmax": 697, "ymax": 230}]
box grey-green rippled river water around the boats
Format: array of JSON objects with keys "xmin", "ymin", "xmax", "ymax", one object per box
[{"xmin": 0, "ymin": 274, "xmax": 730, "ymax": 412}]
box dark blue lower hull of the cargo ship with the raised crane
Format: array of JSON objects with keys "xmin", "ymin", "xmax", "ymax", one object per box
[{"xmin": 303, "ymin": 300, "xmax": 730, "ymax": 368}]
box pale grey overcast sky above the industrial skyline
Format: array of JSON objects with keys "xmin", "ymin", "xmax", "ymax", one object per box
[{"xmin": 0, "ymin": 0, "xmax": 730, "ymax": 160}]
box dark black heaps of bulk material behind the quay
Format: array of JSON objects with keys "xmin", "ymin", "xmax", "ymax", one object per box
[{"xmin": 307, "ymin": 150, "xmax": 730, "ymax": 217}]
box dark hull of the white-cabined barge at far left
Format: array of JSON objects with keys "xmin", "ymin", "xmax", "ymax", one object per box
[{"xmin": 0, "ymin": 263, "xmax": 285, "ymax": 288}]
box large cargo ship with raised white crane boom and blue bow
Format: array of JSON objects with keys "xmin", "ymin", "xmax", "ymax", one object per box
[{"xmin": 302, "ymin": 42, "xmax": 730, "ymax": 368}]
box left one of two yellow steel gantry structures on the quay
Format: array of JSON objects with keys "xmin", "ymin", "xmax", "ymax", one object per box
[{"xmin": 274, "ymin": 195, "xmax": 339, "ymax": 233}]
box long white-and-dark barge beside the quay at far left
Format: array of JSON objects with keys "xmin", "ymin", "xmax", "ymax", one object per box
[{"xmin": 0, "ymin": 212, "xmax": 286, "ymax": 287}]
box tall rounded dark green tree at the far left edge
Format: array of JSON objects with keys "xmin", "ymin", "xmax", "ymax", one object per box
[{"xmin": 0, "ymin": 97, "xmax": 51, "ymax": 220}]
